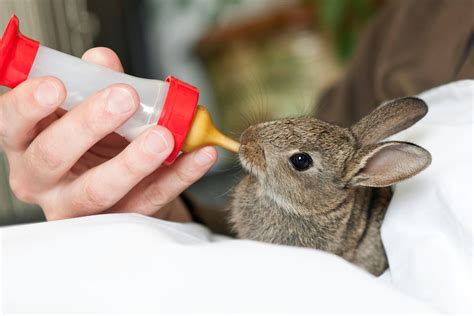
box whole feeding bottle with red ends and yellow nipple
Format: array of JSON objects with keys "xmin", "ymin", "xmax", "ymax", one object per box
[{"xmin": 0, "ymin": 16, "xmax": 239, "ymax": 164}]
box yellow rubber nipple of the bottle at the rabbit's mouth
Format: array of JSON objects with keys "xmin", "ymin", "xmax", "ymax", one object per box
[{"xmin": 181, "ymin": 105, "xmax": 240, "ymax": 153}]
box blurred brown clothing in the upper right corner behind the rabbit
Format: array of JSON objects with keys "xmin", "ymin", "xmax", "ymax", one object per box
[{"xmin": 315, "ymin": 0, "xmax": 474, "ymax": 126}]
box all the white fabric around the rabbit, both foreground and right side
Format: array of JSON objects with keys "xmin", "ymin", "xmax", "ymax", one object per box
[{"xmin": 0, "ymin": 81, "xmax": 474, "ymax": 314}]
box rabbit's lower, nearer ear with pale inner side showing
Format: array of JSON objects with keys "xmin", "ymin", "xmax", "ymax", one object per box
[{"xmin": 346, "ymin": 142, "xmax": 431, "ymax": 187}]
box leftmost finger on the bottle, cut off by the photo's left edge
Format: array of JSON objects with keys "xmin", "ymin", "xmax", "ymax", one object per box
[{"xmin": 0, "ymin": 77, "xmax": 66, "ymax": 151}]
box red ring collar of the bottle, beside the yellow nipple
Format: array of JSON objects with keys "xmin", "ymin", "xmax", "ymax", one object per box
[{"xmin": 158, "ymin": 76, "xmax": 199, "ymax": 165}]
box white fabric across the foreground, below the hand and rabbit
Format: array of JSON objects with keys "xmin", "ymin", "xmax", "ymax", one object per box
[{"xmin": 2, "ymin": 214, "xmax": 429, "ymax": 315}]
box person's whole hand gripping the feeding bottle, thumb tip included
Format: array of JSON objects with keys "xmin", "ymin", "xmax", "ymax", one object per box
[{"xmin": 0, "ymin": 48, "xmax": 217, "ymax": 221}]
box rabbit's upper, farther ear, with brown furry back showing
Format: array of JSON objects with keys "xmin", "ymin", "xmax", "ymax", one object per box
[{"xmin": 351, "ymin": 97, "xmax": 428, "ymax": 146}]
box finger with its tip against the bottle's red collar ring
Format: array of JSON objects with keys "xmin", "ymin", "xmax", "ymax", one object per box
[{"xmin": 55, "ymin": 126, "xmax": 174, "ymax": 216}]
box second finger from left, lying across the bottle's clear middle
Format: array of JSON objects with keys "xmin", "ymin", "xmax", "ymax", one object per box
[{"xmin": 24, "ymin": 84, "xmax": 139, "ymax": 184}]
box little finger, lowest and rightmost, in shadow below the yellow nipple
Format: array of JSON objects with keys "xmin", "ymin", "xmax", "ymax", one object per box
[{"xmin": 113, "ymin": 147, "xmax": 217, "ymax": 218}]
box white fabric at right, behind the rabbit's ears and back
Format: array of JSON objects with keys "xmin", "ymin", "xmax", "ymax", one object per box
[{"xmin": 382, "ymin": 80, "xmax": 474, "ymax": 313}]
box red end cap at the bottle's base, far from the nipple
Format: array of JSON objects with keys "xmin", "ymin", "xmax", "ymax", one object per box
[{"xmin": 0, "ymin": 15, "xmax": 39, "ymax": 88}]
